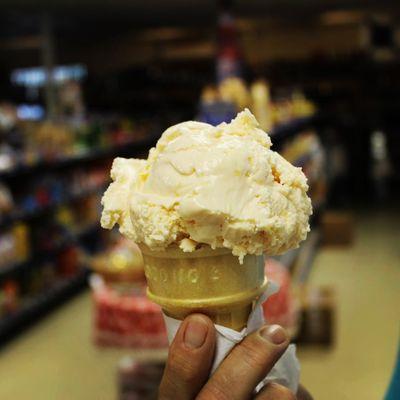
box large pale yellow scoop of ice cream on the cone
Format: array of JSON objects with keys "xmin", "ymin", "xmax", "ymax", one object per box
[{"xmin": 101, "ymin": 110, "xmax": 312, "ymax": 258}]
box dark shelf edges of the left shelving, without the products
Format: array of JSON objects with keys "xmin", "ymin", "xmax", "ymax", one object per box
[{"xmin": 0, "ymin": 135, "xmax": 158, "ymax": 342}]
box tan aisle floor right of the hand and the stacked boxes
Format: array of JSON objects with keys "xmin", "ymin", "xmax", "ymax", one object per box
[{"xmin": 299, "ymin": 212, "xmax": 400, "ymax": 400}]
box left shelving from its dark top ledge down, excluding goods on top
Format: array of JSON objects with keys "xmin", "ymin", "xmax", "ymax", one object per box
[{"xmin": 0, "ymin": 126, "xmax": 163, "ymax": 342}]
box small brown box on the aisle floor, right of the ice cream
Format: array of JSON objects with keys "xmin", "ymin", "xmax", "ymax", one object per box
[{"xmin": 321, "ymin": 211, "xmax": 354, "ymax": 246}]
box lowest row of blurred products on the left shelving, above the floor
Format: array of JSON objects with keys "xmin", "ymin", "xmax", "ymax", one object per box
[{"xmin": 0, "ymin": 219, "xmax": 100, "ymax": 341}]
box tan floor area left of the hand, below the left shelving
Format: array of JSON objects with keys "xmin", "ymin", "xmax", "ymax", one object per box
[{"xmin": 0, "ymin": 292, "xmax": 165, "ymax": 400}]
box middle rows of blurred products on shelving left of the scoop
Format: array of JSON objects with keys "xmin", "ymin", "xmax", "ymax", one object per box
[{"xmin": 0, "ymin": 166, "xmax": 108, "ymax": 278}]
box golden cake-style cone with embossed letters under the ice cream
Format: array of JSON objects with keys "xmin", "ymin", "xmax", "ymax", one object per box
[{"xmin": 141, "ymin": 246, "xmax": 267, "ymax": 331}]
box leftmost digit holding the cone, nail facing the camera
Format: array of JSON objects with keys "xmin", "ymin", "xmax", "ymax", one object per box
[{"xmin": 159, "ymin": 314, "xmax": 215, "ymax": 400}]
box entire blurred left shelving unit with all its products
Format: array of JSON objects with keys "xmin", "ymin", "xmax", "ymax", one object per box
[{"xmin": 0, "ymin": 113, "xmax": 163, "ymax": 340}]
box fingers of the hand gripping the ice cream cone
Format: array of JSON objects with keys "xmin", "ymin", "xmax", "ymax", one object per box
[{"xmin": 159, "ymin": 314, "xmax": 312, "ymax": 400}]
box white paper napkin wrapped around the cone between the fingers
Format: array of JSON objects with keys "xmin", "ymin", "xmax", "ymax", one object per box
[{"xmin": 164, "ymin": 282, "xmax": 300, "ymax": 393}]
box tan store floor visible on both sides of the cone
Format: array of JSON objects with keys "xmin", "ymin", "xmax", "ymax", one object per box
[{"xmin": 0, "ymin": 213, "xmax": 400, "ymax": 400}]
